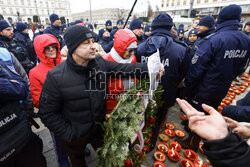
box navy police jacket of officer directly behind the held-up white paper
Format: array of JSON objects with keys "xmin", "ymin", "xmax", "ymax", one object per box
[{"xmin": 136, "ymin": 28, "xmax": 187, "ymax": 106}]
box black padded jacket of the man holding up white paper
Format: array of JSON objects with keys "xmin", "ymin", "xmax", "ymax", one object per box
[{"xmin": 39, "ymin": 55, "xmax": 148, "ymax": 142}]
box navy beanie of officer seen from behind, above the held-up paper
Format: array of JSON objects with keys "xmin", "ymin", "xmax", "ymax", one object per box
[{"xmin": 151, "ymin": 13, "xmax": 174, "ymax": 30}]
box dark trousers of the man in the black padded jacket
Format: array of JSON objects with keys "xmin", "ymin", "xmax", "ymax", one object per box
[{"xmin": 63, "ymin": 126, "xmax": 103, "ymax": 167}]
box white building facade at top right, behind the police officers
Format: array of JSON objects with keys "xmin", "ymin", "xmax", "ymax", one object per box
[{"xmin": 158, "ymin": 0, "xmax": 250, "ymax": 19}]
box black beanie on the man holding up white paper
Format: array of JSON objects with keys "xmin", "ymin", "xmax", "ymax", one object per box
[{"xmin": 64, "ymin": 25, "xmax": 94, "ymax": 55}]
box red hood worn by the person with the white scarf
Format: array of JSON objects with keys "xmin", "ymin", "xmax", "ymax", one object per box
[{"xmin": 114, "ymin": 29, "xmax": 138, "ymax": 57}]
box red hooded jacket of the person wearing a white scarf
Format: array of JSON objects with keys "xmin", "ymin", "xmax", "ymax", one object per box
[{"xmin": 104, "ymin": 29, "xmax": 137, "ymax": 114}]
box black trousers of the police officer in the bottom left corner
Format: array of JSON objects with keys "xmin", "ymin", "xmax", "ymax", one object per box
[{"xmin": 3, "ymin": 132, "xmax": 47, "ymax": 167}]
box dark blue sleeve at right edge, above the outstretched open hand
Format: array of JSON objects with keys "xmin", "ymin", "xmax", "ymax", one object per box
[{"xmin": 222, "ymin": 92, "xmax": 250, "ymax": 122}]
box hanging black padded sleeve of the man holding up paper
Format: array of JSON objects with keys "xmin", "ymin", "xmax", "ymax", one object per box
[{"xmin": 38, "ymin": 71, "xmax": 74, "ymax": 142}]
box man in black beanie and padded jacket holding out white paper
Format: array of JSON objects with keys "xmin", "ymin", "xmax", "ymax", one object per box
[{"xmin": 39, "ymin": 25, "xmax": 163, "ymax": 167}]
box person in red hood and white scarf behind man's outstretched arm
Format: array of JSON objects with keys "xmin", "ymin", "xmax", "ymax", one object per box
[{"xmin": 104, "ymin": 29, "xmax": 138, "ymax": 114}]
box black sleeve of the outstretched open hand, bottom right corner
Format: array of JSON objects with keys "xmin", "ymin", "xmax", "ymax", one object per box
[{"xmin": 202, "ymin": 129, "xmax": 250, "ymax": 167}]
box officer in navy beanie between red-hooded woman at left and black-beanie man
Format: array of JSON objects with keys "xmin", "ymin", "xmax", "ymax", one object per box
[{"xmin": 43, "ymin": 13, "xmax": 64, "ymax": 48}]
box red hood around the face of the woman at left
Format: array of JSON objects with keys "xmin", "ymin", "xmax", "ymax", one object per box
[{"xmin": 34, "ymin": 34, "xmax": 61, "ymax": 65}]
